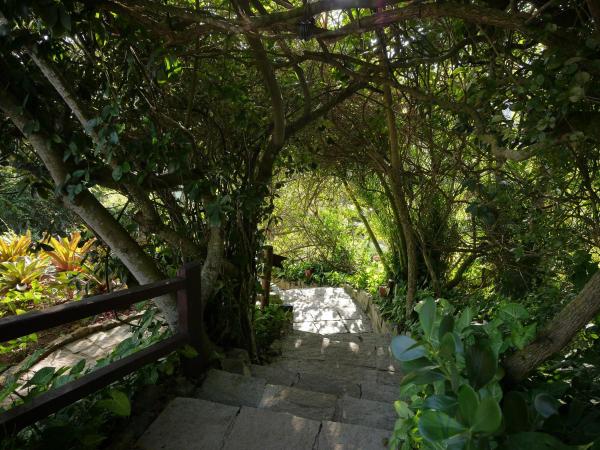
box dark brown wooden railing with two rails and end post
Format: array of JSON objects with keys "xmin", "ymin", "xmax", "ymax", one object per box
[{"xmin": 0, "ymin": 263, "xmax": 202, "ymax": 435}]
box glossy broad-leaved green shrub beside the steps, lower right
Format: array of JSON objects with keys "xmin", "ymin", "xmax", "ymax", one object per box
[{"xmin": 391, "ymin": 298, "xmax": 588, "ymax": 450}]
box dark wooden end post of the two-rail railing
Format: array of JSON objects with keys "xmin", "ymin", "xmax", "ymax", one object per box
[{"xmin": 177, "ymin": 261, "xmax": 206, "ymax": 376}]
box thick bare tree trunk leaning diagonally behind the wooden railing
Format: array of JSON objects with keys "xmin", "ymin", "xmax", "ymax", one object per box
[{"xmin": 0, "ymin": 91, "xmax": 177, "ymax": 329}]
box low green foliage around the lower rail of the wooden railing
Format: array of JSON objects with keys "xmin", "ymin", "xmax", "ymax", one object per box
[{"xmin": 0, "ymin": 308, "xmax": 185, "ymax": 450}]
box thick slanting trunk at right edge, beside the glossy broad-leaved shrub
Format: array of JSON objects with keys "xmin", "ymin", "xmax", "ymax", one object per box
[{"xmin": 504, "ymin": 271, "xmax": 600, "ymax": 382}]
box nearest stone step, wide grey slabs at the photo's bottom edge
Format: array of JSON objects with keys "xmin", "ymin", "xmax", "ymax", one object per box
[{"xmin": 137, "ymin": 398, "xmax": 390, "ymax": 450}]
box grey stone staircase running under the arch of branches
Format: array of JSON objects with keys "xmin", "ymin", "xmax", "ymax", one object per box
[{"xmin": 138, "ymin": 288, "xmax": 400, "ymax": 450}]
